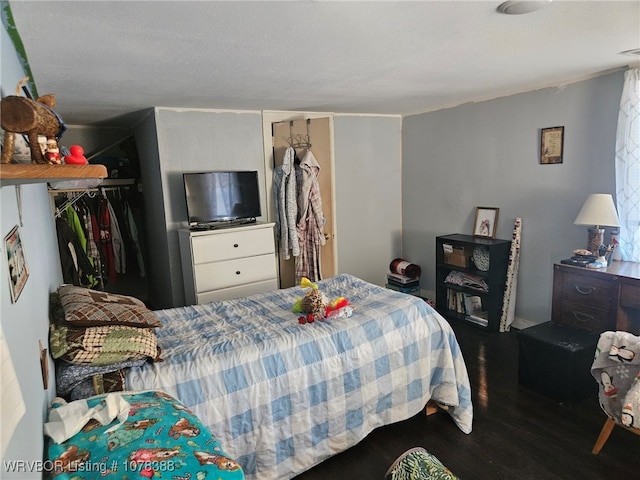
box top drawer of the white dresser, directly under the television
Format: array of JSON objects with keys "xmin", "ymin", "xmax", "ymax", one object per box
[{"xmin": 191, "ymin": 228, "xmax": 274, "ymax": 264}]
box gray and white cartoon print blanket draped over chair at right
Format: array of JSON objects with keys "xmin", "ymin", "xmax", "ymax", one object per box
[{"xmin": 591, "ymin": 332, "xmax": 640, "ymax": 428}]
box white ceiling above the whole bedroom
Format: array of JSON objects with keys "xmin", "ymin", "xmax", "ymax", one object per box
[{"xmin": 3, "ymin": 0, "xmax": 640, "ymax": 125}]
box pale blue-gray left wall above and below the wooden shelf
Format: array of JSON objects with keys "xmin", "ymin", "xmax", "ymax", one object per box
[{"xmin": 0, "ymin": 28, "xmax": 62, "ymax": 479}]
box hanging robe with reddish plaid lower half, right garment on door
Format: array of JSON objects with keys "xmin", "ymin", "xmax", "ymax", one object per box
[{"xmin": 295, "ymin": 150, "xmax": 326, "ymax": 284}]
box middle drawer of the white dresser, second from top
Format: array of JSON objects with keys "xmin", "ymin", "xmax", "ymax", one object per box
[{"xmin": 194, "ymin": 253, "xmax": 277, "ymax": 294}]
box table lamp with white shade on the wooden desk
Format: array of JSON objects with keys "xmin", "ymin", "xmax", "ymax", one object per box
[{"xmin": 573, "ymin": 193, "xmax": 620, "ymax": 264}]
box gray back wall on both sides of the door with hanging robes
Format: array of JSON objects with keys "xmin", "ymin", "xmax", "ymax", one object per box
[{"xmin": 135, "ymin": 108, "xmax": 401, "ymax": 308}]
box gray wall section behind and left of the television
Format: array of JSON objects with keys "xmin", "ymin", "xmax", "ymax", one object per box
[{"xmin": 135, "ymin": 108, "xmax": 266, "ymax": 308}]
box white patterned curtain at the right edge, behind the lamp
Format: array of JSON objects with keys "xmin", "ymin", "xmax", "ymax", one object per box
[{"xmin": 616, "ymin": 68, "xmax": 640, "ymax": 262}]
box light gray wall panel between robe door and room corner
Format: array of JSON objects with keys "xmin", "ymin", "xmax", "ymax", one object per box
[{"xmin": 334, "ymin": 115, "xmax": 402, "ymax": 285}]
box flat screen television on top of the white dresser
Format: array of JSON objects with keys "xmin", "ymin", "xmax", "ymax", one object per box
[{"xmin": 183, "ymin": 171, "xmax": 262, "ymax": 227}]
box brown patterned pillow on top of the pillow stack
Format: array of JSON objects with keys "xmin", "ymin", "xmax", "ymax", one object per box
[{"xmin": 58, "ymin": 285, "xmax": 162, "ymax": 328}]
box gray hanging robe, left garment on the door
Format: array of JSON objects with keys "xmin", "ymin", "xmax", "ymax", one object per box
[{"xmin": 273, "ymin": 147, "xmax": 300, "ymax": 260}]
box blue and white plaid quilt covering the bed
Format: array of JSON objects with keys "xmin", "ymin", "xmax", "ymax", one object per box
[{"xmin": 127, "ymin": 275, "xmax": 473, "ymax": 480}]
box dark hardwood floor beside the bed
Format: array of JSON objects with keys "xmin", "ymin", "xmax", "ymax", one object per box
[{"xmin": 295, "ymin": 323, "xmax": 640, "ymax": 480}]
